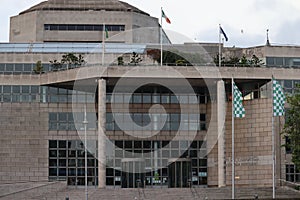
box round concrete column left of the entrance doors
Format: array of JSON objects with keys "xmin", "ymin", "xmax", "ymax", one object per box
[{"xmin": 98, "ymin": 79, "xmax": 106, "ymax": 188}]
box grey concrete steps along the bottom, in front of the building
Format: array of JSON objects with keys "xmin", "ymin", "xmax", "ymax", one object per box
[{"xmin": 15, "ymin": 187, "xmax": 300, "ymax": 200}]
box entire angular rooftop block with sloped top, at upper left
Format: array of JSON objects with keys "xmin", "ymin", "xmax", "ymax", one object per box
[{"xmin": 10, "ymin": 0, "xmax": 167, "ymax": 43}]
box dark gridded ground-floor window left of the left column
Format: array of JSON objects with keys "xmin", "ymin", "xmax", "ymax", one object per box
[{"xmin": 49, "ymin": 140, "xmax": 98, "ymax": 185}]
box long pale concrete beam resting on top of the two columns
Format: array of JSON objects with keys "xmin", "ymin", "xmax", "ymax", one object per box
[{"xmin": 0, "ymin": 66, "xmax": 300, "ymax": 85}]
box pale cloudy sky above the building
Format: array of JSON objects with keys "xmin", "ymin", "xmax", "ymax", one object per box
[{"xmin": 0, "ymin": 0, "xmax": 300, "ymax": 47}]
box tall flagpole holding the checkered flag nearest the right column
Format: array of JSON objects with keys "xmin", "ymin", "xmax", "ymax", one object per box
[{"xmin": 231, "ymin": 76, "xmax": 235, "ymax": 199}]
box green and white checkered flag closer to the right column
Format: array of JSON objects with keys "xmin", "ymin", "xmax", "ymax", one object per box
[{"xmin": 233, "ymin": 83, "xmax": 245, "ymax": 118}]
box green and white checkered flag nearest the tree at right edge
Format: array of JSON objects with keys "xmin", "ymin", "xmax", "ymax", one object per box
[{"xmin": 273, "ymin": 79, "xmax": 286, "ymax": 117}]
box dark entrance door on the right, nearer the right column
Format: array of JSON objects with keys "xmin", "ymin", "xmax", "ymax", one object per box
[{"xmin": 169, "ymin": 158, "xmax": 192, "ymax": 188}]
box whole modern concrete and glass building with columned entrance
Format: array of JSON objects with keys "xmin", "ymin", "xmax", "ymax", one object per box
[{"xmin": 0, "ymin": 0, "xmax": 300, "ymax": 192}]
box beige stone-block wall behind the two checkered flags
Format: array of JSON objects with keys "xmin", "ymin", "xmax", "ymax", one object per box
[{"xmin": 226, "ymin": 99, "xmax": 280, "ymax": 186}]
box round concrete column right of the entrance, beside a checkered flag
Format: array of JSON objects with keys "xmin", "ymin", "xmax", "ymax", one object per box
[{"xmin": 217, "ymin": 80, "xmax": 226, "ymax": 187}]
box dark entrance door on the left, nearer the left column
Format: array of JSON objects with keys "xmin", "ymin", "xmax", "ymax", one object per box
[{"xmin": 121, "ymin": 158, "xmax": 145, "ymax": 188}]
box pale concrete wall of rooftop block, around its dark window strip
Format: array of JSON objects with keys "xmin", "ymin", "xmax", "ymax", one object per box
[{"xmin": 10, "ymin": 10, "xmax": 159, "ymax": 43}]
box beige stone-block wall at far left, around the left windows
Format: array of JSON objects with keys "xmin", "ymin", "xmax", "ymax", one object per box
[{"xmin": 0, "ymin": 103, "xmax": 97, "ymax": 184}]
